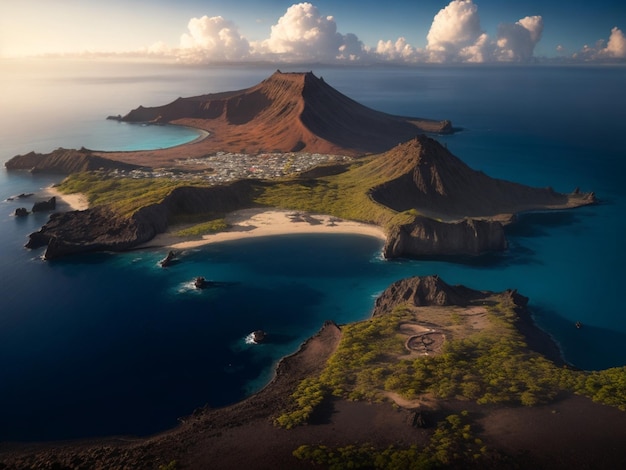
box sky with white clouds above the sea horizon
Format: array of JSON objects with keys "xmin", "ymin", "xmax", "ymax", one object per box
[{"xmin": 0, "ymin": 0, "xmax": 626, "ymax": 64}]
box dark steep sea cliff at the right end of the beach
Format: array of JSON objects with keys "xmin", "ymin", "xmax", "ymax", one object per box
[{"xmin": 383, "ymin": 216, "xmax": 507, "ymax": 258}]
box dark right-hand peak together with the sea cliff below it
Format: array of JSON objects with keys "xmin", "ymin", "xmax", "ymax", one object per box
[{"xmin": 356, "ymin": 136, "xmax": 596, "ymax": 258}]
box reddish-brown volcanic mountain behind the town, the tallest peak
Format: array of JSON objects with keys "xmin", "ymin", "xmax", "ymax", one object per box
[{"xmin": 107, "ymin": 72, "xmax": 452, "ymax": 165}]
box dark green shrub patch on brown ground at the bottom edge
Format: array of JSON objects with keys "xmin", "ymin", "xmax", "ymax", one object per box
[{"xmin": 293, "ymin": 411, "xmax": 489, "ymax": 470}]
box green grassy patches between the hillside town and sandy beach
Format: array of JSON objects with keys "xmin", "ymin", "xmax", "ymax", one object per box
[{"xmin": 54, "ymin": 152, "xmax": 418, "ymax": 236}]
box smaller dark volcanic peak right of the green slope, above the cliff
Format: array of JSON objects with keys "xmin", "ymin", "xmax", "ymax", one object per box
[{"xmin": 361, "ymin": 136, "xmax": 593, "ymax": 219}]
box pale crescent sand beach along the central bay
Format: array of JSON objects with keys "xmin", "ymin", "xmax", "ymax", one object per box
[{"xmin": 144, "ymin": 209, "xmax": 385, "ymax": 250}]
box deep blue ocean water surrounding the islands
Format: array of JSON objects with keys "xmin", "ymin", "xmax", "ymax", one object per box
[{"xmin": 0, "ymin": 61, "xmax": 626, "ymax": 441}]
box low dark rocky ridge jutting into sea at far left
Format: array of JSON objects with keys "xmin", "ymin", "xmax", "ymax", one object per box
[{"xmin": 4, "ymin": 148, "xmax": 139, "ymax": 175}]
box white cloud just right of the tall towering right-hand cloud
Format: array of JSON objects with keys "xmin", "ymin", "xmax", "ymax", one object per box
[{"xmin": 496, "ymin": 16, "xmax": 543, "ymax": 62}]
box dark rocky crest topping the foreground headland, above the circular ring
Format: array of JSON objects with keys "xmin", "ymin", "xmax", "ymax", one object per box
[{"xmin": 372, "ymin": 276, "xmax": 491, "ymax": 316}]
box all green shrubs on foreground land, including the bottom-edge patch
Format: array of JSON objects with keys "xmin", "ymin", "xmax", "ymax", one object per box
[{"xmin": 282, "ymin": 298, "xmax": 626, "ymax": 470}]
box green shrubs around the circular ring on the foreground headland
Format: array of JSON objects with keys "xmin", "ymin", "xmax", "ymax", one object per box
[{"xmin": 275, "ymin": 302, "xmax": 626, "ymax": 428}]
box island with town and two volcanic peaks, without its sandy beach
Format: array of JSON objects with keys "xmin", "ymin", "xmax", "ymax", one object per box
[{"xmin": 6, "ymin": 72, "xmax": 596, "ymax": 259}]
